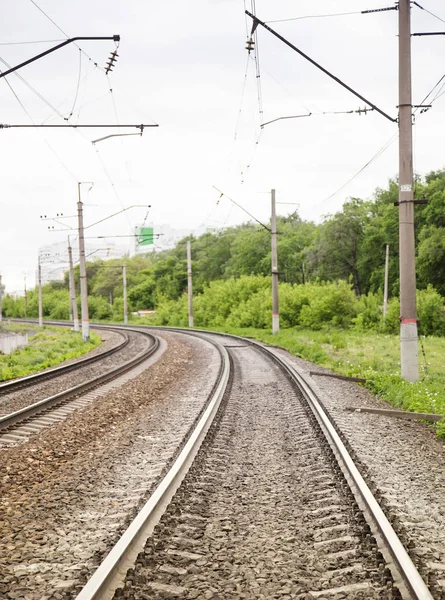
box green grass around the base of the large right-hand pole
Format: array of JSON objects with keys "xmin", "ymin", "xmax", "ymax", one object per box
[{"xmin": 204, "ymin": 328, "xmax": 445, "ymax": 437}]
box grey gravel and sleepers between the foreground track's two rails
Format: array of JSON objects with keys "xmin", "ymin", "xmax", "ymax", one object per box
[{"xmin": 115, "ymin": 341, "xmax": 393, "ymax": 600}]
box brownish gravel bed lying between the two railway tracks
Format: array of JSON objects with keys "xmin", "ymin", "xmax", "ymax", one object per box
[{"xmin": 0, "ymin": 333, "xmax": 220, "ymax": 600}]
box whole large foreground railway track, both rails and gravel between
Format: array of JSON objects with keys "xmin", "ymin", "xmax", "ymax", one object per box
[{"xmin": 73, "ymin": 332, "xmax": 434, "ymax": 600}]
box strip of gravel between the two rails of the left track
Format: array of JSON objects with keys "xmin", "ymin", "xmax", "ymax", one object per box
[{"xmin": 0, "ymin": 330, "xmax": 151, "ymax": 416}]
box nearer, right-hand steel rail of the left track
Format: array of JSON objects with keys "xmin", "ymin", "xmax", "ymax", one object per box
[{"xmin": 0, "ymin": 327, "xmax": 159, "ymax": 431}]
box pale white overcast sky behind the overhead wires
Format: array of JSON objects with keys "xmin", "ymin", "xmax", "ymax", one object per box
[{"xmin": 0, "ymin": 0, "xmax": 445, "ymax": 291}]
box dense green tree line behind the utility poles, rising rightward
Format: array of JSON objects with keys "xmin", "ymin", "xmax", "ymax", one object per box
[{"xmin": 3, "ymin": 170, "xmax": 445, "ymax": 332}]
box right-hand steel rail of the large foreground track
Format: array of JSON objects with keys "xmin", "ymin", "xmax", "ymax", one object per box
[{"xmin": 140, "ymin": 327, "xmax": 433, "ymax": 600}]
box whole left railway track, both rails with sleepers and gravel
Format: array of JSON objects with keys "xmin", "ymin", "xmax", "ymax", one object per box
[{"xmin": 0, "ymin": 327, "xmax": 159, "ymax": 447}]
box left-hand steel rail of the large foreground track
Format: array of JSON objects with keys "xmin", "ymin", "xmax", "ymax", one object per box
[{"xmin": 76, "ymin": 332, "xmax": 230, "ymax": 600}]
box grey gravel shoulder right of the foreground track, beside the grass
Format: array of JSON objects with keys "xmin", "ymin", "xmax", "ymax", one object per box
[{"xmin": 276, "ymin": 351, "xmax": 445, "ymax": 599}]
